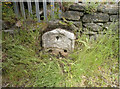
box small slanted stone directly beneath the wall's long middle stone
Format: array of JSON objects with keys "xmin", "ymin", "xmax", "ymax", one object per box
[{"xmin": 83, "ymin": 23, "xmax": 102, "ymax": 32}]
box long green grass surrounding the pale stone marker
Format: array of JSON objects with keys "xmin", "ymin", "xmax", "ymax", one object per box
[{"xmin": 2, "ymin": 21, "xmax": 118, "ymax": 87}]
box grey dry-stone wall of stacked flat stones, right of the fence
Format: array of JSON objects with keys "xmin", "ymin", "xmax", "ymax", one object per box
[{"xmin": 63, "ymin": 3, "xmax": 118, "ymax": 39}]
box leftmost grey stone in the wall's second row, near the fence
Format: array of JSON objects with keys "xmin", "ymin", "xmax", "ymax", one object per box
[{"xmin": 63, "ymin": 11, "xmax": 83, "ymax": 20}]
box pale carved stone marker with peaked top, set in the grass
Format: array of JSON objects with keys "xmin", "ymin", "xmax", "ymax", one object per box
[{"xmin": 42, "ymin": 28, "xmax": 75, "ymax": 56}]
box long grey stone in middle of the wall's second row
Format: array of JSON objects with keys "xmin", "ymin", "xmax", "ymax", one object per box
[{"xmin": 82, "ymin": 13, "xmax": 109, "ymax": 22}]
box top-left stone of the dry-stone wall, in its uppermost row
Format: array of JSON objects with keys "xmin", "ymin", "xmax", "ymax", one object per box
[{"xmin": 69, "ymin": 3, "xmax": 85, "ymax": 11}]
